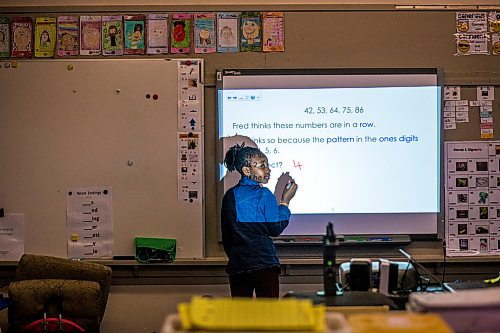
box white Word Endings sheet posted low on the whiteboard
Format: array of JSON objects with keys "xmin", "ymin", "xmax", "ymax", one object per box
[{"xmin": 66, "ymin": 187, "xmax": 113, "ymax": 258}]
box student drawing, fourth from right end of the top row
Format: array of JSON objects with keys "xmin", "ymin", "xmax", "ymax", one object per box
[{"xmin": 193, "ymin": 13, "xmax": 216, "ymax": 53}]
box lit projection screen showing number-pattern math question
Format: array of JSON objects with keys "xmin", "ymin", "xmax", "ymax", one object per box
[{"xmin": 217, "ymin": 69, "xmax": 442, "ymax": 236}]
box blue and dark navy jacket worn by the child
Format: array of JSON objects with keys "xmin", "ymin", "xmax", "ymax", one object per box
[{"xmin": 221, "ymin": 177, "xmax": 290, "ymax": 275}]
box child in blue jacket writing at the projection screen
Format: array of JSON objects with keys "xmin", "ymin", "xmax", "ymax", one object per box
[{"xmin": 221, "ymin": 144, "xmax": 297, "ymax": 298}]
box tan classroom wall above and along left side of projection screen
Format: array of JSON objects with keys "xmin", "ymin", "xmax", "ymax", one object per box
[{"xmin": 0, "ymin": 1, "xmax": 500, "ymax": 257}]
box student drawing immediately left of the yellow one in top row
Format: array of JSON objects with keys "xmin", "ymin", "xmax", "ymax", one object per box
[{"xmin": 11, "ymin": 17, "xmax": 33, "ymax": 58}]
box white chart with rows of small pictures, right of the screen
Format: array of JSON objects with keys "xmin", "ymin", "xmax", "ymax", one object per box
[{"xmin": 445, "ymin": 141, "xmax": 500, "ymax": 256}]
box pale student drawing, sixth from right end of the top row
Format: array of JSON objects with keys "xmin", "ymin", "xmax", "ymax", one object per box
[{"xmin": 146, "ymin": 13, "xmax": 168, "ymax": 54}]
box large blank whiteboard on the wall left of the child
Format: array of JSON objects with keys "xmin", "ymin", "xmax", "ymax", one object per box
[{"xmin": 0, "ymin": 59, "xmax": 204, "ymax": 258}]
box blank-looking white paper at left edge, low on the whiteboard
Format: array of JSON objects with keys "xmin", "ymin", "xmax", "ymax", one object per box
[{"xmin": 0, "ymin": 214, "xmax": 24, "ymax": 261}]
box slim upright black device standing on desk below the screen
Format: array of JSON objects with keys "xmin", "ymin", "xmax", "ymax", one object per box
[{"xmin": 323, "ymin": 222, "xmax": 337, "ymax": 296}]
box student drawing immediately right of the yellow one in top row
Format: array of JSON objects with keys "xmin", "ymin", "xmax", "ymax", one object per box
[{"xmin": 57, "ymin": 16, "xmax": 80, "ymax": 57}]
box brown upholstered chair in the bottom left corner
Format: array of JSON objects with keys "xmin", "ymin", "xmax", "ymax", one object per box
[{"xmin": 8, "ymin": 254, "xmax": 111, "ymax": 333}]
